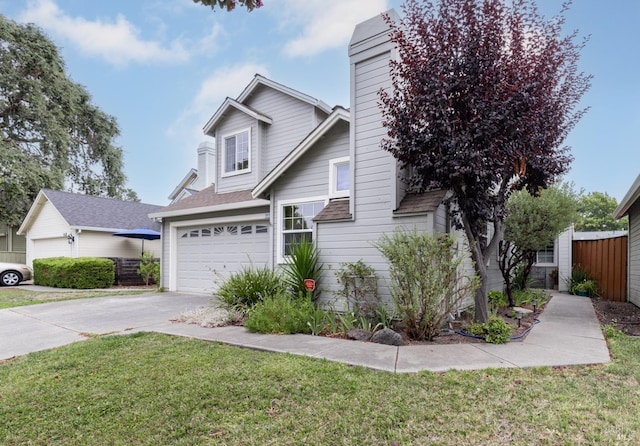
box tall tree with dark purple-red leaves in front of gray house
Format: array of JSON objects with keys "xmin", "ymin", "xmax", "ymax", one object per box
[{"xmin": 380, "ymin": 0, "xmax": 590, "ymax": 322}]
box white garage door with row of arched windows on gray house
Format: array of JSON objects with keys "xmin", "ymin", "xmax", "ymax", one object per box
[{"xmin": 176, "ymin": 222, "xmax": 269, "ymax": 293}]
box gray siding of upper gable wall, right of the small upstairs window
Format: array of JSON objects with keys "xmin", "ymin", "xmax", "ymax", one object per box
[{"xmin": 246, "ymin": 86, "xmax": 326, "ymax": 179}]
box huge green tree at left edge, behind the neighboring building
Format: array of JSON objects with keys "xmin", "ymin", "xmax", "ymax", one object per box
[{"xmin": 0, "ymin": 15, "xmax": 136, "ymax": 226}]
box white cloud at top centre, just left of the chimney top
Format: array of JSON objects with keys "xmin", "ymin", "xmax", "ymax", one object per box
[{"xmin": 278, "ymin": 0, "xmax": 388, "ymax": 57}]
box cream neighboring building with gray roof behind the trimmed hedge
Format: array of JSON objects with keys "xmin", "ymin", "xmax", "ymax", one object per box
[{"xmin": 18, "ymin": 189, "xmax": 161, "ymax": 265}]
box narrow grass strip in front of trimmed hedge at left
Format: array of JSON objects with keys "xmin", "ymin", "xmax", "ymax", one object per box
[{"xmin": 0, "ymin": 287, "xmax": 152, "ymax": 310}]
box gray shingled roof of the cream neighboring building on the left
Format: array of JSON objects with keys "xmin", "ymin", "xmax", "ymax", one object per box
[{"xmin": 42, "ymin": 189, "xmax": 161, "ymax": 231}]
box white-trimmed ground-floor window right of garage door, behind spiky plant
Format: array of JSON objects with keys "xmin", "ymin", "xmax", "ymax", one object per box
[{"xmin": 279, "ymin": 200, "xmax": 325, "ymax": 258}]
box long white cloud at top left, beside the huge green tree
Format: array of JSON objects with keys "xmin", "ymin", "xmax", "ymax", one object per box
[{"xmin": 19, "ymin": 0, "xmax": 189, "ymax": 65}]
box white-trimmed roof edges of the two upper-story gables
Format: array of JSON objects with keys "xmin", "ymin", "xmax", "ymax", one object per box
[{"xmin": 203, "ymin": 74, "xmax": 331, "ymax": 134}]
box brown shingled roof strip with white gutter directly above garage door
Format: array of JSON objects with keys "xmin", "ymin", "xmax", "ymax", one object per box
[{"xmin": 150, "ymin": 185, "xmax": 270, "ymax": 218}]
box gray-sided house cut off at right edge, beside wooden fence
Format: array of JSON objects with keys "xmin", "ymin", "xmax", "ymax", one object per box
[{"xmin": 613, "ymin": 175, "xmax": 640, "ymax": 306}]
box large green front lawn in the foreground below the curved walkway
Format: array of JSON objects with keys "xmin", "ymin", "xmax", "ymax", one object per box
[{"xmin": 0, "ymin": 334, "xmax": 640, "ymax": 446}]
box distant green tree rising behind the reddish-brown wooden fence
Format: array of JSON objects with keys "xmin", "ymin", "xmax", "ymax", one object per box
[{"xmin": 575, "ymin": 192, "xmax": 629, "ymax": 231}]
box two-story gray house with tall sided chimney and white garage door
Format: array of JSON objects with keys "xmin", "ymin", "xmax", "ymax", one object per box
[{"xmin": 150, "ymin": 11, "xmax": 458, "ymax": 304}]
